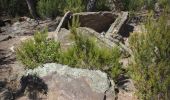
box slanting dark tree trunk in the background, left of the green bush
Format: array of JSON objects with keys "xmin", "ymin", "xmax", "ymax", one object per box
[{"xmin": 26, "ymin": 0, "xmax": 38, "ymax": 19}]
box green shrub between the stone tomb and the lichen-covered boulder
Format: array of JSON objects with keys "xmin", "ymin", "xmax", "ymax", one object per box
[{"xmin": 63, "ymin": 17, "xmax": 122, "ymax": 79}]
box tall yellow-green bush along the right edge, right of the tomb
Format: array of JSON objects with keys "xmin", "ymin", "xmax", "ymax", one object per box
[{"xmin": 130, "ymin": 15, "xmax": 170, "ymax": 100}]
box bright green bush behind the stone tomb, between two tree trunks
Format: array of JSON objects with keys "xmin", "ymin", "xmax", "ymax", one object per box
[{"xmin": 37, "ymin": 0, "xmax": 85, "ymax": 18}]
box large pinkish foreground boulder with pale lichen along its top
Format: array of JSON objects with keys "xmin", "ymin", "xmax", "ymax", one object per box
[{"xmin": 20, "ymin": 63, "xmax": 115, "ymax": 100}]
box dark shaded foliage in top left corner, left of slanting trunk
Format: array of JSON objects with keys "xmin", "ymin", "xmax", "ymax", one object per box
[{"xmin": 0, "ymin": 0, "xmax": 28, "ymax": 16}]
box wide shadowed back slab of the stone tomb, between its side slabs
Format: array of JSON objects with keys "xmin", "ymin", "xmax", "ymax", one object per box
[{"xmin": 73, "ymin": 12, "xmax": 117, "ymax": 32}]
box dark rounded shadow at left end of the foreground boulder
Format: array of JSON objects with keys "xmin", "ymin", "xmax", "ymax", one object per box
[{"xmin": 14, "ymin": 75, "xmax": 48, "ymax": 100}]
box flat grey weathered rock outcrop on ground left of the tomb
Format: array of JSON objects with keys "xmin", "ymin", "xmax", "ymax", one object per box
[{"xmin": 1, "ymin": 17, "xmax": 59, "ymax": 36}]
